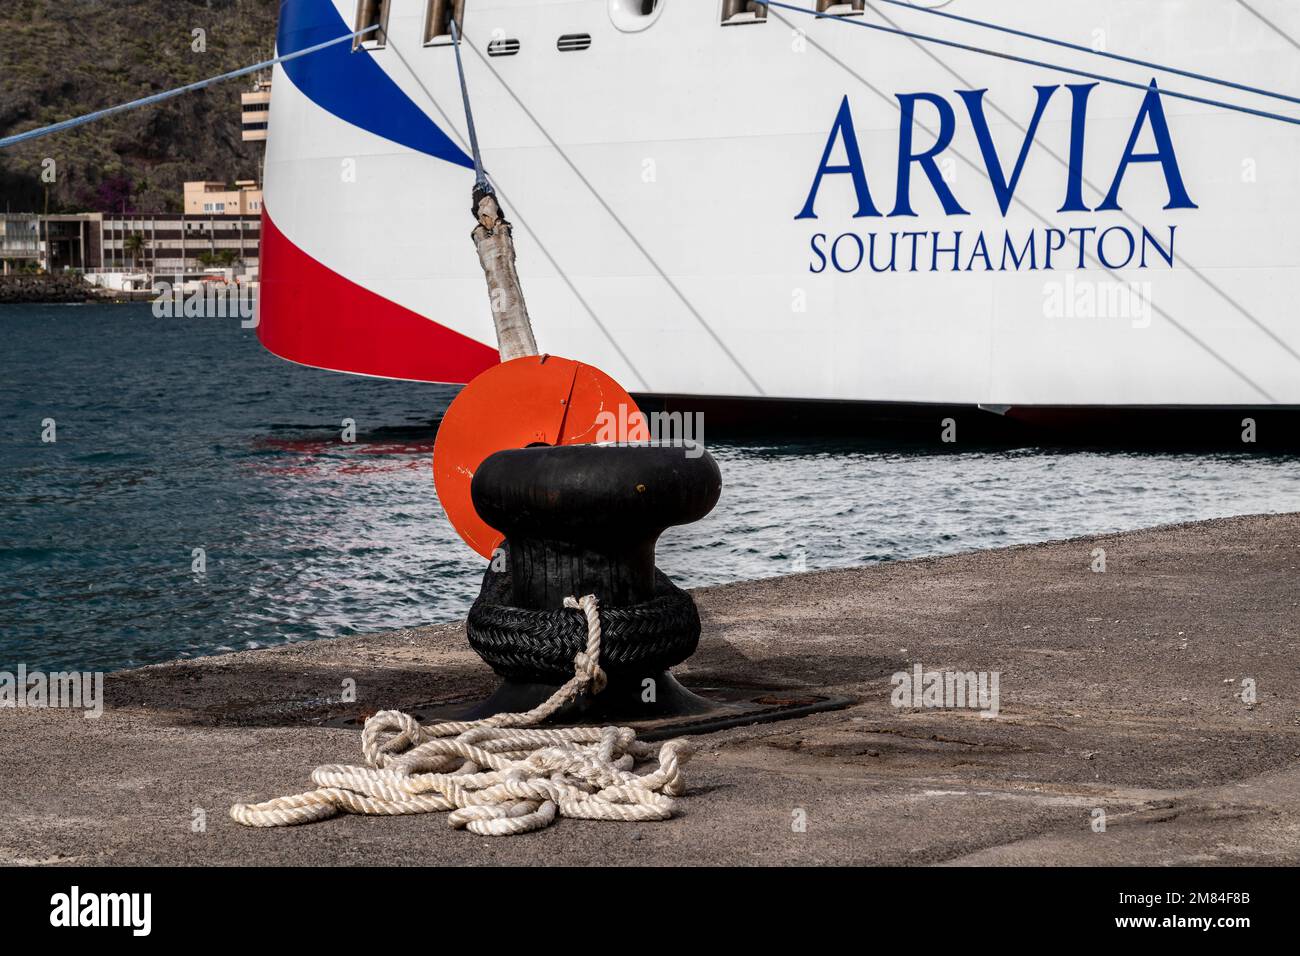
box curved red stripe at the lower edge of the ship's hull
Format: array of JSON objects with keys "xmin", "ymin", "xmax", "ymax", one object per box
[{"xmin": 257, "ymin": 209, "xmax": 499, "ymax": 384}]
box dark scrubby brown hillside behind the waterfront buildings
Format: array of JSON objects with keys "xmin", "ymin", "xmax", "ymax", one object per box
[{"xmin": 0, "ymin": 0, "xmax": 278, "ymax": 212}]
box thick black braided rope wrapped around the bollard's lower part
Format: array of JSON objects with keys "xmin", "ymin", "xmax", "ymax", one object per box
[{"xmin": 465, "ymin": 567, "xmax": 699, "ymax": 684}]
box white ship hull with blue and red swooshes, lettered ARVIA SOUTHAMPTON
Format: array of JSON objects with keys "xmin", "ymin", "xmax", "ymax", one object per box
[{"xmin": 260, "ymin": 0, "xmax": 1300, "ymax": 407}]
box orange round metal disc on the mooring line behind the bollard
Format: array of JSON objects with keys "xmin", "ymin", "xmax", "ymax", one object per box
[{"xmin": 433, "ymin": 355, "xmax": 649, "ymax": 558}]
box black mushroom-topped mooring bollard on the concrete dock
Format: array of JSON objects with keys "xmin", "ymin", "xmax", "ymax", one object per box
[{"xmin": 467, "ymin": 444, "xmax": 722, "ymax": 721}]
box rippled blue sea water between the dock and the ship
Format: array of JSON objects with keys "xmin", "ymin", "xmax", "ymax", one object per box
[{"xmin": 0, "ymin": 304, "xmax": 1300, "ymax": 670}]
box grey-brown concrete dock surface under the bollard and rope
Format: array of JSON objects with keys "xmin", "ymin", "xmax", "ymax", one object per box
[{"xmin": 0, "ymin": 514, "xmax": 1300, "ymax": 865}]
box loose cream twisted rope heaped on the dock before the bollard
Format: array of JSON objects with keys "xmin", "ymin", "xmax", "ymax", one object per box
[{"xmin": 230, "ymin": 594, "xmax": 694, "ymax": 836}]
